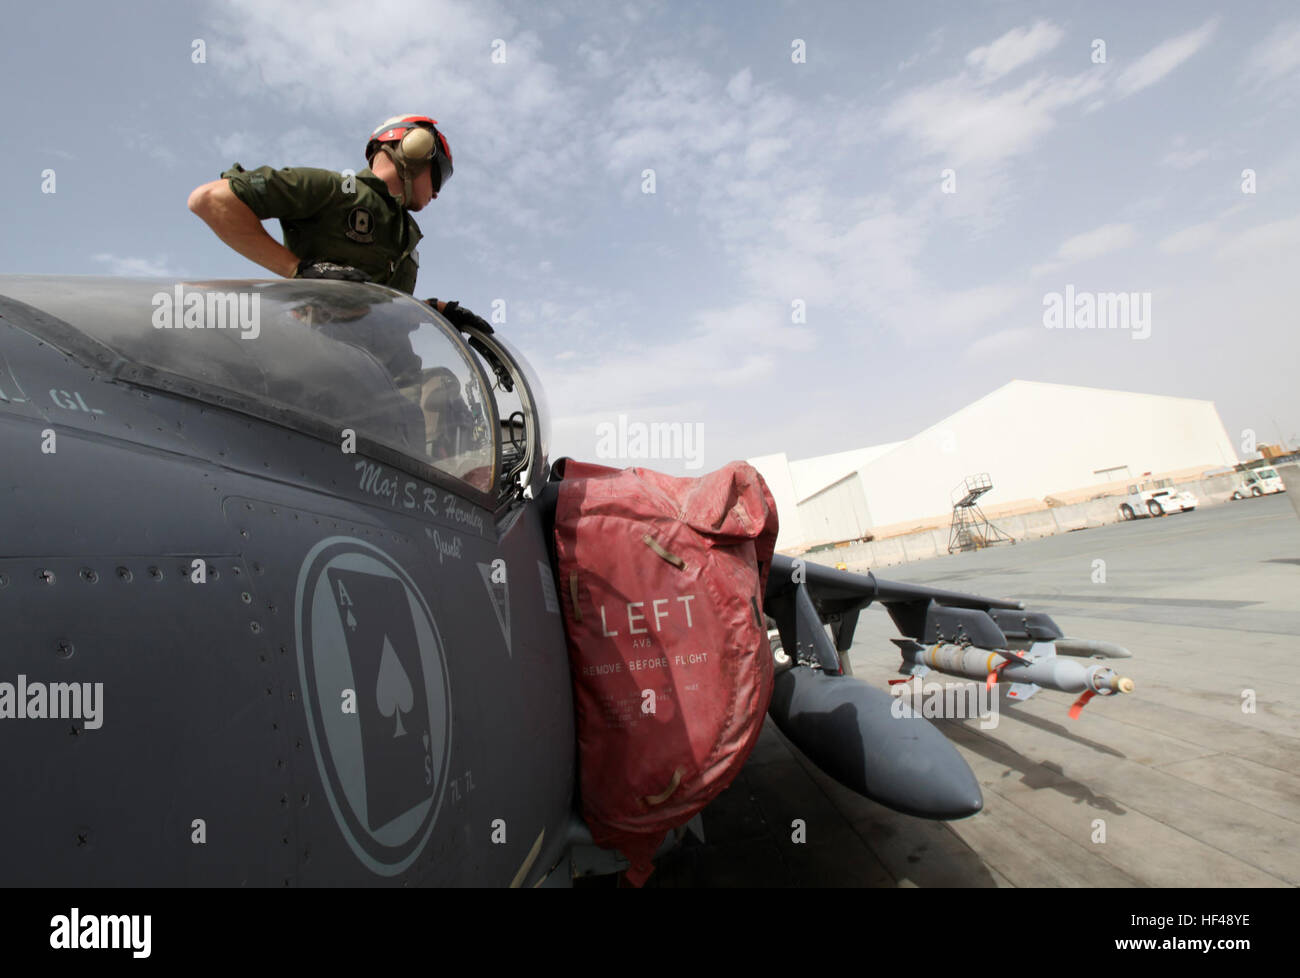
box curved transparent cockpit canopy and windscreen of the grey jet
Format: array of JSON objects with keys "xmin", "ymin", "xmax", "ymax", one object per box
[{"xmin": 0, "ymin": 276, "xmax": 547, "ymax": 507}]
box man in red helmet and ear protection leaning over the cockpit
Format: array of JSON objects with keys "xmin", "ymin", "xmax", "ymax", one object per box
[{"xmin": 190, "ymin": 116, "xmax": 491, "ymax": 333}]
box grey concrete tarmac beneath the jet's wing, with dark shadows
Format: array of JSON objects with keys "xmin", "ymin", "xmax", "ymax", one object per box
[{"xmin": 650, "ymin": 496, "xmax": 1300, "ymax": 887}]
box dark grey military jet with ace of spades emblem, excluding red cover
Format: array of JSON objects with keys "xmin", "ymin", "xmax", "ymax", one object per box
[{"xmin": 0, "ymin": 276, "xmax": 1133, "ymax": 886}]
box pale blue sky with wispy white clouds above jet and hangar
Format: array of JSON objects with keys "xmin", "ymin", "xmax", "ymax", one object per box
[{"xmin": 0, "ymin": 0, "xmax": 1300, "ymax": 471}]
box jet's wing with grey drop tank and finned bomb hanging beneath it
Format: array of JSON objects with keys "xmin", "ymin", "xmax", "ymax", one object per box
[{"xmin": 764, "ymin": 554, "xmax": 1132, "ymax": 819}]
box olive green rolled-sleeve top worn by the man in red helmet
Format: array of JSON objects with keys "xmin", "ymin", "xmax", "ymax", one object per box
[{"xmin": 221, "ymin": 163, "xmax": 423, "ymax": 293}]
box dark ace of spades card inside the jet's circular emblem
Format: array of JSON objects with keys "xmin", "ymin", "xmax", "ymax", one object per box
[{"xmin": 328, "ymin": 568, "xmax": 432, "ymax": 832}]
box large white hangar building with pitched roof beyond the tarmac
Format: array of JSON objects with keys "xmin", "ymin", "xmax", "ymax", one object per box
[{"xmin": 749, "ymin": 380, "xmax": 1238, "ymax": 550}]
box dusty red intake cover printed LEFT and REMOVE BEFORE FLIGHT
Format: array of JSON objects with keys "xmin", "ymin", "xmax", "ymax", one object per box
[{"xmin": 555, "ymin": 460, "xmax": 777, "ymax": 886}]
